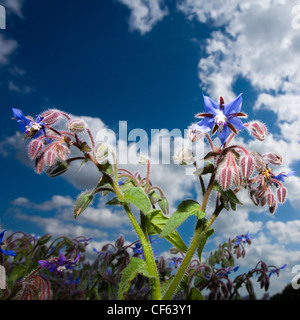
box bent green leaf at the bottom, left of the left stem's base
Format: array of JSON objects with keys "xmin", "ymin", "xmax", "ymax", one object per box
[{"xmin": 118, "ymin": 257, "xmax": 154, "ymax": 300}]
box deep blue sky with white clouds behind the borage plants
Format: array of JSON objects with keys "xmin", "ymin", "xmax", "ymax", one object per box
[{"xmin": 0, "ymin": 0, "xmax": 300, "ymax": 293}]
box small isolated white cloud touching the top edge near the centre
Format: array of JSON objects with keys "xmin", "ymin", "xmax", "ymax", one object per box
[{"xmin": 118, "ymin": 0, "xmax": 168, "ymax": 35}]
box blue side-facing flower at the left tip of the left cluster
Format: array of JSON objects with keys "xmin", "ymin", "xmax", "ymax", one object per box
[{"xmin": 12, "ymin": 108, "xmax": 47, "ymax": 139}]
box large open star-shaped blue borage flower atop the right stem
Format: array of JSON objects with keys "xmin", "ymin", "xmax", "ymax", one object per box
[{"xmin": 192, "ymin": 94, "xmax": 247, "ymax": 145}]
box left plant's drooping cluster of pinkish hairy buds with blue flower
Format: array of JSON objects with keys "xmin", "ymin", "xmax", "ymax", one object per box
[{"xmin": 12, "ymin": 108, "xmax": 94, "ymax": 177}]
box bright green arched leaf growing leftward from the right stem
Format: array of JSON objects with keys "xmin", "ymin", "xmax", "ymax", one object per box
[{"xmin": 160, "ymin": 200, "xmax": 205, "ymax": 237}]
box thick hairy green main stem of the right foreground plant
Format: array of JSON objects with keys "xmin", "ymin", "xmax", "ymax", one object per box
[{"xmin": 162, "ymin": 174, "xmax": 218, "ymax": 300}]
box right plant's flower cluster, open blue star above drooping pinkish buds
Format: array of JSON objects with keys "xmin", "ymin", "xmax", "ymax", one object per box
[{"xmin": 184, "ymin": 94, "xmax": 295, "ymax": 213}]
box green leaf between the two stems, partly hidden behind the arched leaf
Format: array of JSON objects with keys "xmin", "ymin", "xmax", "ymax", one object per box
[{"xmin": 146, "ymin": 209, "xmax": 188, "ymax": 252}]
